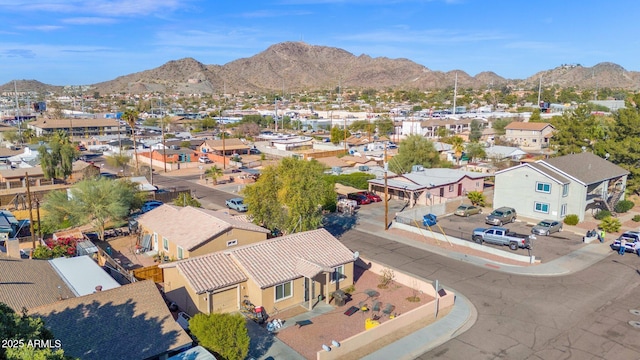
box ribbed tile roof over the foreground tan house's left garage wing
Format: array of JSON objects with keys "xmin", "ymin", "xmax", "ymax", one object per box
[{"xmin": 168, "ymin": 252, "xmax": 247, "ymax": 294}]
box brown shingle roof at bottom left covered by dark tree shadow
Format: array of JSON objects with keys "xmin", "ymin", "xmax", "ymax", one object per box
[{"xmin": 30, "ymin": 280, "xmax": 193, "ymax": 360}]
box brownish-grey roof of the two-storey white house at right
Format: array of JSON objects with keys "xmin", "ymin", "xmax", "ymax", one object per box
[{"xmin": 540, "ymin": 152, "xmax": 629, "ymax": 185}]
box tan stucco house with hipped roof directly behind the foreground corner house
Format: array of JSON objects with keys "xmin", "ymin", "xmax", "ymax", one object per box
[{"xmin": 138, "ymin": 204, "xmax": 269, "ymax": 260}]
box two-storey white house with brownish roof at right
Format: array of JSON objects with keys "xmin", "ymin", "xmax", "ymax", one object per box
[{"xmin": 493, "ymin": 152, "xmax": 629, "ymax": 221}]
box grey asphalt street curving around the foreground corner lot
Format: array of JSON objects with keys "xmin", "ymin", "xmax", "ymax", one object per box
[{"xmin": 130, "ymin": 172, "xmax": 640, "ymax": 360}]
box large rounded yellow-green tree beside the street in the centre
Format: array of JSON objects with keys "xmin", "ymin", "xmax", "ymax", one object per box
[{"xmin": 244, "ymin": 158, "xmax": 336, "ymax": 233}]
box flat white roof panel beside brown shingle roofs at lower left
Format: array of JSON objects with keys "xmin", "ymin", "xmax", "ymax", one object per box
[{"xmin": 49, "ymin": 255, "xmax": 120, "ymax": 296}]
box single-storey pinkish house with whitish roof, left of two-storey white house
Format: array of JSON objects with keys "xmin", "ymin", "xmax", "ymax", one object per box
[{"xmin": 369, "ymin": 167, "xmax": 488, "ymax": 207}]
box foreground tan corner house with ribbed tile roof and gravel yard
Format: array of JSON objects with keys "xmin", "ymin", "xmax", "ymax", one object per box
[{"xmin": 160, "ymin": 229, "xmax": 355, "ymax": 315}]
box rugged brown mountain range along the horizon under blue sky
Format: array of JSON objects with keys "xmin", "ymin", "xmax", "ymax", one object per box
[{"xmin": 0, "ymin": 42, "xmax": 640, "ymax": 95}]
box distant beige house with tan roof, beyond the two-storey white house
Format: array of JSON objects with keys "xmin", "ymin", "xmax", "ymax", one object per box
[{"xmin": 504, "ymin": 121, "xmax": 555, "ymax": 151}]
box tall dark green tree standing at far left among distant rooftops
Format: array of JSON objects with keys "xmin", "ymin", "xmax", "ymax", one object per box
[{"xmin": 38, "ymin": 130, "xmax": 78, "ymax": 179}]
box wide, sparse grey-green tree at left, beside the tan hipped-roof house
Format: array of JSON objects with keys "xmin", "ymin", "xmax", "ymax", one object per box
[{"xmin": 42, "ymin": 178, "xmax": 144, "ymax": 240}]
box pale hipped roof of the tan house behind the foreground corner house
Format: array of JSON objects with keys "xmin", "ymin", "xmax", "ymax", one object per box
[{"xmin": 138, "ymin": 204, "xmax": 269, "ymax": 251}]
